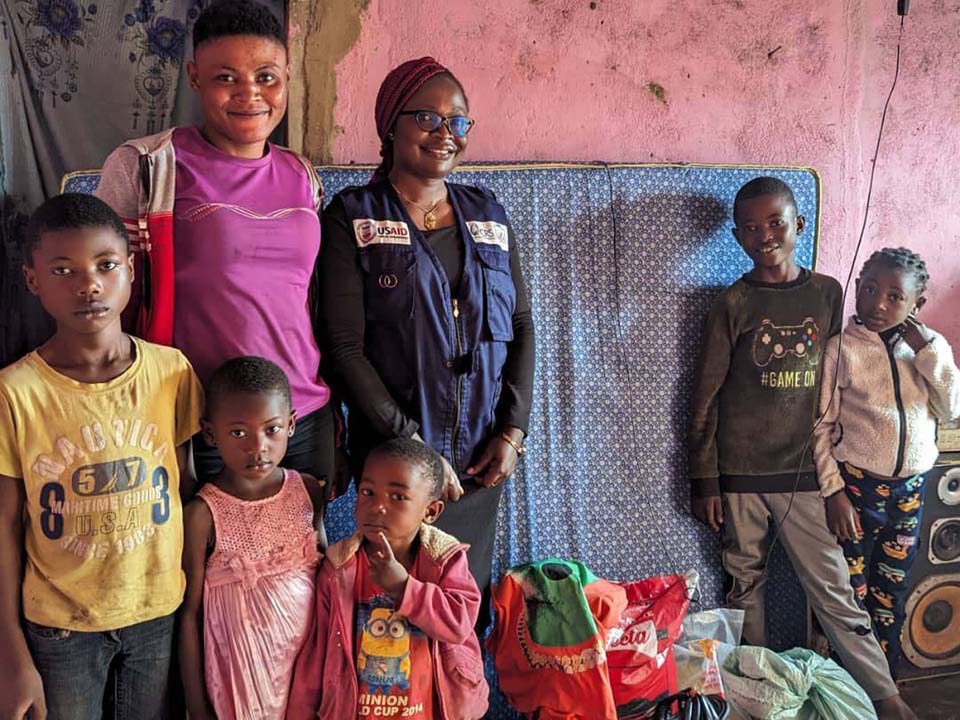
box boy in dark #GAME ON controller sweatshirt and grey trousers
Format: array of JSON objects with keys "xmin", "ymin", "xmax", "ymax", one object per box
[{"xmin": 689, "ymin": 177, "xmax": 916, "ymax": 720}]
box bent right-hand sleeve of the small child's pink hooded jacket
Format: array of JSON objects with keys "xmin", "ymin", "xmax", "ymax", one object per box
[{"xmin": 397, "ymin": 550, "xmax": 480, "ymax": 645}]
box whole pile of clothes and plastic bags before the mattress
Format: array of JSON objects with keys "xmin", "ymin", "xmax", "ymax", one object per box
[{"xmin": 488, "ymin": 558, "xmax": 876, "ymax": 720}]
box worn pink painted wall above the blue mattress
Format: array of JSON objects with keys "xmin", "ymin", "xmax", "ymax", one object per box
[{"xmin": 324, "ymin": 0, "xmax": 960, "ymax": 346}]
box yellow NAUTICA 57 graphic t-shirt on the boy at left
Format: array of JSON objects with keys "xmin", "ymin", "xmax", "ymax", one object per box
[{"xmin": 0, "ymin": 338, "xmax": 203, "ymax": 632}]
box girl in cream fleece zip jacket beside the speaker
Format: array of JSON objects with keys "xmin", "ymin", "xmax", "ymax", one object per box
[{"xmin": 813, "ymin": 248, "xmax": 960, "ymax": 674}]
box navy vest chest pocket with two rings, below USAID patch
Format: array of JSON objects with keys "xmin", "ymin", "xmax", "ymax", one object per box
[{"xmin": 360, "ymin": 248, "xmax": 417, "ymax": 323}]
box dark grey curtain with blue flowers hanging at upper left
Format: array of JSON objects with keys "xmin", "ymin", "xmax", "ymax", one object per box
[{"xmin": 0, "ymin": 0, "xmax": 284, "ymax": 365}]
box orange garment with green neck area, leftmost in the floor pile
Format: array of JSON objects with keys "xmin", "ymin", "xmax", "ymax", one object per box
[{"xmin": 488, "ymin": 559, "xmax": 627, "ymax": 720}]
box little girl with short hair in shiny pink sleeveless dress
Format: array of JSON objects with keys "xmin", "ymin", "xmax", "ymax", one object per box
[{"xmin": 180, "ymin": 357, "xmax": 323, "ymax": 720}]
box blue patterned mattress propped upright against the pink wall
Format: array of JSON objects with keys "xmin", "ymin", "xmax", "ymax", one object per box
[{"xmin": 68, "ymin": 164, "xmax": 820, "ymax": 718}]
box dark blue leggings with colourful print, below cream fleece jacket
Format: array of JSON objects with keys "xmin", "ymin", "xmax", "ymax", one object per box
[{"xmin": 840, "ymin": 463, "xmax": 925, "ymax": 678}]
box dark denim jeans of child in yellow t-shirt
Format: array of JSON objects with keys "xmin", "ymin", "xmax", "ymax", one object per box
[{"xmin": 24, "ymin": 615, "xmax": 174, "ymax": 720}]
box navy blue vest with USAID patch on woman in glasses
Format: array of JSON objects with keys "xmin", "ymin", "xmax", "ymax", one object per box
[{"xmin": 340, "ymin": 181, "xmax": 517, "ymax": 472}]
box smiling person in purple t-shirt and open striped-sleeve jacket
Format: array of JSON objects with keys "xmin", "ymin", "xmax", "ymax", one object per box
[{"xmin": 97, "ymin": 0, "xmax": 334, "ymax": 506}]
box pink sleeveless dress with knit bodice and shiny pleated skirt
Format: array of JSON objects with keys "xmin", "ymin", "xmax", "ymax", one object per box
[{"xmin": 199, "ymin": 470, "xmax": 319, "ymax": 720}]
